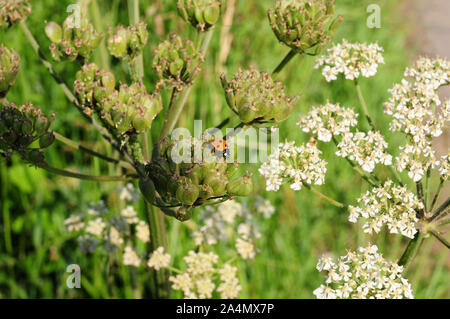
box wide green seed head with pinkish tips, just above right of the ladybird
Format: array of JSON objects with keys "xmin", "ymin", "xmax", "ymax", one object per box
[{"xmin": 221, "ymin": 69, "xmax": 296, "ymax": 125}]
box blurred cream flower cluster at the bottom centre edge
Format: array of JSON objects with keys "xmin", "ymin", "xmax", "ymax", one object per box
[{"xmin": 169, "ymin": 251, "xmax": 241, "ymax": 299}]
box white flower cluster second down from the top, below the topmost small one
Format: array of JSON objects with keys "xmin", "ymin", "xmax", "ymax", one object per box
[{"xmin": 297, "ymin": 102, "xmax": 358, "ymax": 142}]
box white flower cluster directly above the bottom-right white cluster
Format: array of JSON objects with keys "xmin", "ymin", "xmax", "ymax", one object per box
[{"xmin": 348, "ymin": 180, "xmax": 423, "ymax": 238}]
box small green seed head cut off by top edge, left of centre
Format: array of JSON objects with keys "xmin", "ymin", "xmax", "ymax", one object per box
[{"xmin": 177, "ymin": 0, "xmax": 222, "ymax": 31}]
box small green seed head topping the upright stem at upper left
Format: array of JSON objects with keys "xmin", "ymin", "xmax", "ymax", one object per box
[{"xmin": 108, "ymin": 21, "xmax": 148, "ymax": 61}]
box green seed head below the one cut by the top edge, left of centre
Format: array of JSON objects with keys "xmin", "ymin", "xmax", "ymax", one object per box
[{"xmin": 153, "ymin": 34, "xmax": 203, "ymax": 90}]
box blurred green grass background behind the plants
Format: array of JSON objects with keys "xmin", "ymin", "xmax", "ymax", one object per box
[{"xmin": 0, "ymin": 0, "xmax": 450, "ymax": 298}]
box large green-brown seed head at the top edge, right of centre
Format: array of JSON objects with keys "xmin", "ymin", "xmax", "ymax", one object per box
[{"xmin": 268, "ymin": 0, "xmax": 343, "ymax": 54}]
